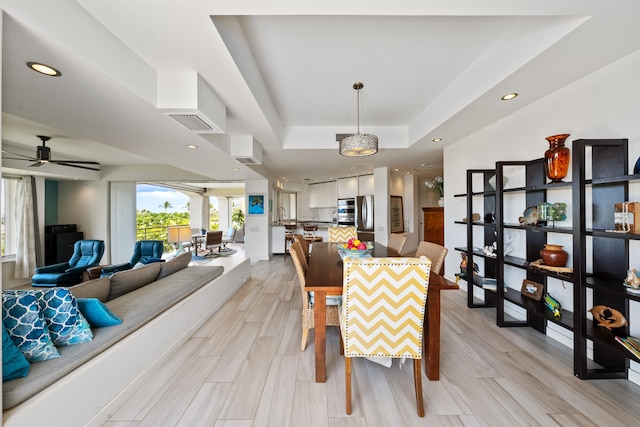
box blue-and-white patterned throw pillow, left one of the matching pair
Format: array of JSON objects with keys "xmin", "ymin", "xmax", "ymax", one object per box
[{"xmin": 2, "ymin": 291, "xmax": 60, "ymax": 362}]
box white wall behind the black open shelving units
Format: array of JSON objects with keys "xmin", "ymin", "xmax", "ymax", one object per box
[{"xmin": 444, "ymin": 46, "xmax": 640, "ymax": 380}]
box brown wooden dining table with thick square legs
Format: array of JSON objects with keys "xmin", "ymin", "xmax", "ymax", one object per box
[{"xmin": 305, "ymin": 242, "xmax": 459, "ymax": 383}]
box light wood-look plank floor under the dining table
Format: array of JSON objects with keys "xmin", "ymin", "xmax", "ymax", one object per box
[{"xmin": 104, "ymin": 251, "xmax": 640, "ymax": 427}]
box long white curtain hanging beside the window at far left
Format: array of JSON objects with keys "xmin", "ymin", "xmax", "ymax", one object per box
[{"xmin": 14, "ymin": 177, "xmax": 37, "ymax": 279}]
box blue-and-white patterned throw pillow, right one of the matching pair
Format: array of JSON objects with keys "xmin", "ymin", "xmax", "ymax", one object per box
[{"xmin": 5, "ymin": 288, "xmax": 93, "ymax": 346}]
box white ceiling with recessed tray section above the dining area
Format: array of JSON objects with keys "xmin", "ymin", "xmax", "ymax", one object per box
[{"xmin": 0, "ymin": 0, "xmax": 640, "ymax": 186}]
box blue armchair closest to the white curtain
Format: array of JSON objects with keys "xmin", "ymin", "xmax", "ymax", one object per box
[{"xmin": 31, "ymin": 240, "xmax": 104, "ymax": 287}]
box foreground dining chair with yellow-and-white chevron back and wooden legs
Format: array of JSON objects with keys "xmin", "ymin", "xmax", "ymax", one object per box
[{"xmin": 340, "ymin": 257, "xmax": 431, "ymax": 417}]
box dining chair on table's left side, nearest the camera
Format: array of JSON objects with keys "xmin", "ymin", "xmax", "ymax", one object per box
[{"xmin": 291, "ymin": 242, "xmax": 342, "ymax": 351}]
